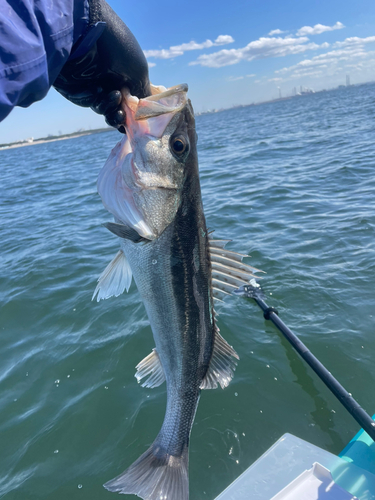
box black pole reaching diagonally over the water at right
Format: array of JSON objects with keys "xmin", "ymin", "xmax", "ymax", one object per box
[{"xmin": 233, "ymin": 280, "xmax": 375, "ymax": 441}]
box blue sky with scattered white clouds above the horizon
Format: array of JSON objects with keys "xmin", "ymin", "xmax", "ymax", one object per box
[{"xmin": 0, "ymin": 0, "xmax": 375, "ymax": 142}]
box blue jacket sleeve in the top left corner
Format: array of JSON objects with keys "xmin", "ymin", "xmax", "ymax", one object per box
[{"xmin": 0, "ymin": 0, "xmax": 89, "ymax": 121}]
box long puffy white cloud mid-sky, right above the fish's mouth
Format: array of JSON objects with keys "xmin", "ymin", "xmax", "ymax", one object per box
[{"xmin": 190, "ymin": 37, "xmax": 320, "ymax": 68}]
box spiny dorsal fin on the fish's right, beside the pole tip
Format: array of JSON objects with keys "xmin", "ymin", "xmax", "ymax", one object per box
[{"xmin": 209, "ymin": 238, "xmax": 263, "ymax": 300}]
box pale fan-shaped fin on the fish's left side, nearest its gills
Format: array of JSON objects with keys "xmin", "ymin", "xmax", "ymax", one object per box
[{"xmin": 91, "ymin": 250, "xmax": 132, "ymax": 302}]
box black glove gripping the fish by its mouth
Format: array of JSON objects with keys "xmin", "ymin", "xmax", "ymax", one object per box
[{"xmin": 53, "ymin": 0, "xmax": 151, "ymax": 132}]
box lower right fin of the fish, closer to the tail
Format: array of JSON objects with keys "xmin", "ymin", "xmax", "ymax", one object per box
[{"xmin": 200, "ymin": 328, "xmax": 240, "ymax": 389}]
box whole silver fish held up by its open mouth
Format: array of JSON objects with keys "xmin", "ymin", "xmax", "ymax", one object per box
[{"xmin": 93, "ymin": 84, "xmax": 259, "ymax": 500}]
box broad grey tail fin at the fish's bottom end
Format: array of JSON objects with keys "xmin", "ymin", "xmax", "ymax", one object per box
[{"xmin": 104, "ymin": 445, "xmax": 189, "ymax": 500}]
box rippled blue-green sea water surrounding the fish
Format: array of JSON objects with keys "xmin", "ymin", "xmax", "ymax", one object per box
[{"xmin": 0, "ymin": 85, "xmax": 375, "ymax": 500}]
